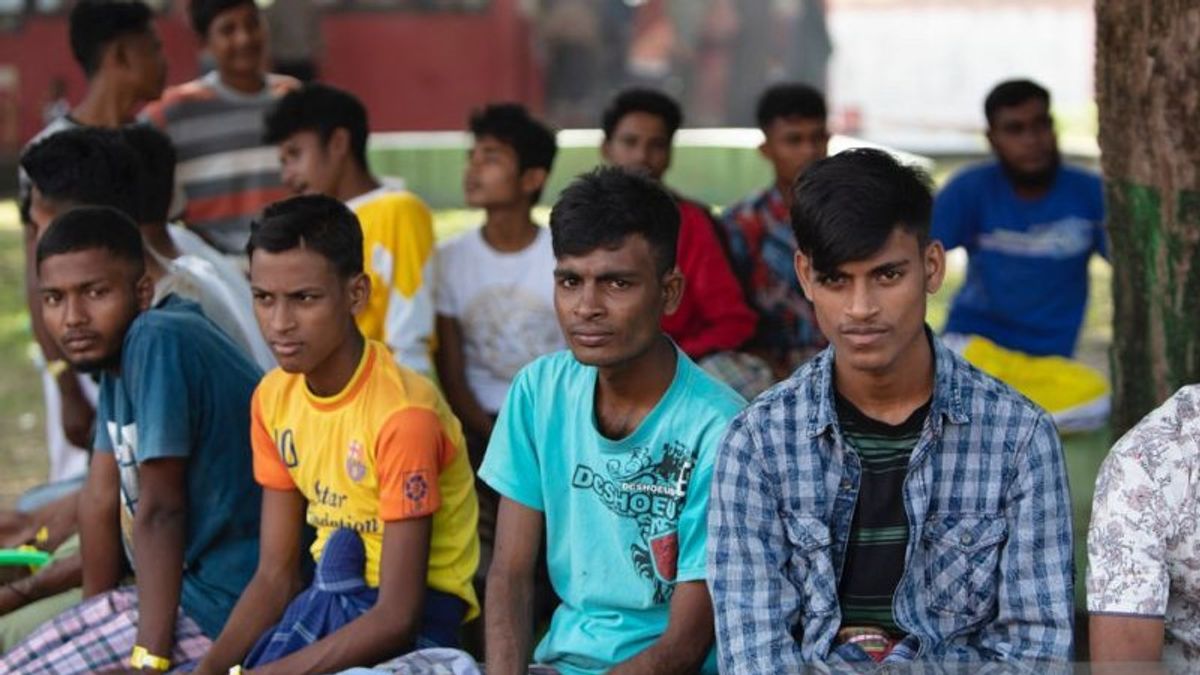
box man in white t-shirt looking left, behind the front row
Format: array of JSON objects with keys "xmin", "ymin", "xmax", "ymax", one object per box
[{"xmin": 434, "ymin": 103, "xmax": 563, "ymax": 590}]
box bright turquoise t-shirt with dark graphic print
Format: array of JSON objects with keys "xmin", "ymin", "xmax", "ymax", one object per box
[{"xmin": 479, "ymin": 350, "xmax": 745, "ymax": 673}]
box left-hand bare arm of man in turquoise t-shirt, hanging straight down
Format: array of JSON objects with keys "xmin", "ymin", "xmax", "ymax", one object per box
[{"xmin": 485, "ymin": 497, "xmax": 544, "ymax": 675}]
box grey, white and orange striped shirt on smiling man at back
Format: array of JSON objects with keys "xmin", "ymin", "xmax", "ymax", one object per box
[{"xmin": 143, "ymin": 71, "xmax": 298, "ymax": 253}]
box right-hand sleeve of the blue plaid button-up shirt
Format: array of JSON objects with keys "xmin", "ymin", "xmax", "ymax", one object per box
[{"xmin": 961, "ymin": 413, "xmax": 1075, "ymax": 663}]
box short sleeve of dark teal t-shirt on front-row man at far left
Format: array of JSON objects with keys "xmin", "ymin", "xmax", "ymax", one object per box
[{"xmin": 121, "ymin": 322, "xmax": 193, "ymax": 464}]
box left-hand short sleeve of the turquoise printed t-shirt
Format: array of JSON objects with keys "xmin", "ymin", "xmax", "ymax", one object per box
[{"xmin": 479, "ymin": 366, "xmax": 545, "ymax": 510}]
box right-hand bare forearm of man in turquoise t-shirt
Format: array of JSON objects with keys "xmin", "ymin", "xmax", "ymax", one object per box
[{"xmin": 611, "ymin": 581, "xmax": 713, "ymax": 675}]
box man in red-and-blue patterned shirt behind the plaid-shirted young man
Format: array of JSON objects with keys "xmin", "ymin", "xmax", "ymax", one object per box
[{"xmin": 721, "ymin": 84, "xmax": 829, "ymax": 380}]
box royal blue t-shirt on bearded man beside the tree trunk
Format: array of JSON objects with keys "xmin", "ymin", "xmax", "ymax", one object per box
[{"xmin": 932, "ymin": 162, "xmax": 1108, "ymax": 357}]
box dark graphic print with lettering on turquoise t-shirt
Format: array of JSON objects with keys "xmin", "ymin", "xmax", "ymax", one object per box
[{"xmin": 571, "ymin": 441, "xmax": 697, "ymax": 603}]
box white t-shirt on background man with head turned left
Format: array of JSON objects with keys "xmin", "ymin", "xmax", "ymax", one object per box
[{"xmin": 434, "ymin": 227, "xmax": 566, "ymax": 413}]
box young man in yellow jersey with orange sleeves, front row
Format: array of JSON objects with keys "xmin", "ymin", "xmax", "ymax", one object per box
[{"xmin": 198, "ymin": 196, "xmax": 479, "ymax": 673}]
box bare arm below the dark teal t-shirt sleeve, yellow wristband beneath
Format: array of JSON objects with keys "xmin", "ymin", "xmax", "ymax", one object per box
[{"xmin": 133, "ymin": 458, "xmax": 187, "ymax": 655}]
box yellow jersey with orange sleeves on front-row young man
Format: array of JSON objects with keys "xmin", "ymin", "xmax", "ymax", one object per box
[{"xmin": 251, "ymin": 341, "xmax": 479, "ymax": 619}]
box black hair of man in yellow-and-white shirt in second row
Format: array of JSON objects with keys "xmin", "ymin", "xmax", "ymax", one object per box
[{"xmin": 264, "ymin": 83, "xmax": 370, "ymax": 169}]
